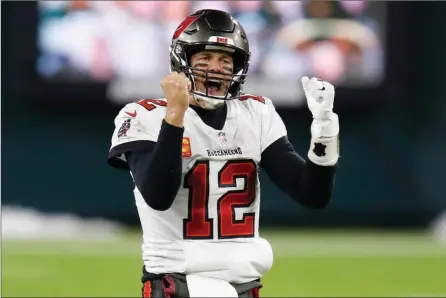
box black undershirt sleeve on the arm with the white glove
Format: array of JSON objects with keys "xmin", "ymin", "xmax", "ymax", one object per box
[{"xmin": 261, "ymin": 136, "xmax": 337, "ymax": 209}]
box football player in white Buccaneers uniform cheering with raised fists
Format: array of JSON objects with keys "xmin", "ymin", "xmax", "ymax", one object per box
[{"xmin": 108, "ymin": 10, "xmax": 339, "ymax": 297}]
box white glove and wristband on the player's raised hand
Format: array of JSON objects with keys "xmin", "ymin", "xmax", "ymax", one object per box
[{"xmin": 302, "ymin": 77, "xmax": 339, "ymax": 166}]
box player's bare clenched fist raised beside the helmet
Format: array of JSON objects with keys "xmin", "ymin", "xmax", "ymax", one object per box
[{"xmin": 161, "ymin": 72, "xmax": 190, "ymax": 127}]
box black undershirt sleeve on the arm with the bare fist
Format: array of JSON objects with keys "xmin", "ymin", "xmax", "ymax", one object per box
[{"xmin": 125, "ymin": 120, "xmax": 184, "ymax": 211}]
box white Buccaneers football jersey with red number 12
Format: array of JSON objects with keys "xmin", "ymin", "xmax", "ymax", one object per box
[{"xmin": 110, "ymin": 95, "xmax": 286, "ymax": 283}]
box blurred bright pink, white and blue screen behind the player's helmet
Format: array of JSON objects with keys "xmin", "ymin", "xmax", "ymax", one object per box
[{"xmin": 38, "ymin": 0, "xmax": 384, "ymax": 83}]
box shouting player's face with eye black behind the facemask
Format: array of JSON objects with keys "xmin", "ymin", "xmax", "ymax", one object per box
[{"xmin": 190, "ymin": 51, "xmax": 234, "ymax": 96}]
